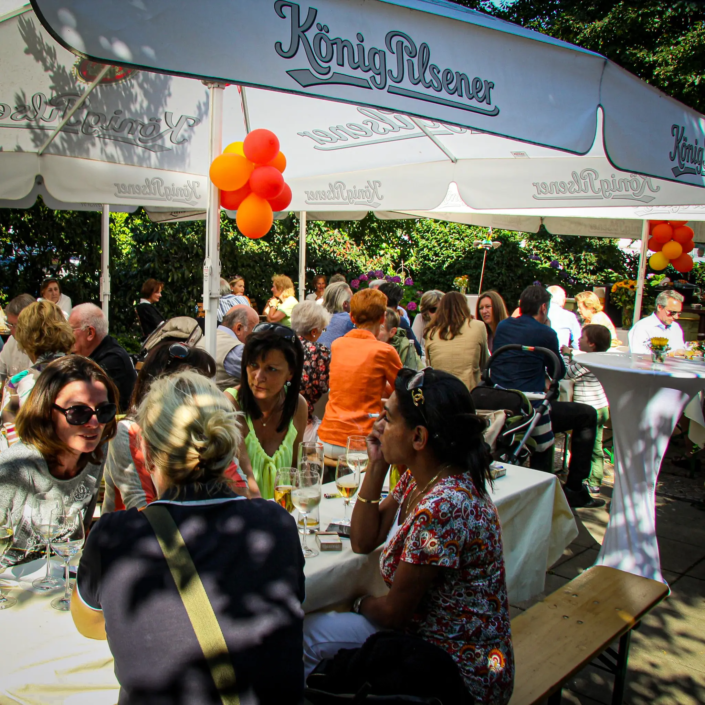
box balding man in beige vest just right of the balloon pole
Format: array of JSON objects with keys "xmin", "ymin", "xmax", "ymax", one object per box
[{"xmin": 196, "ymin": 304, "xmax": 259, "ymax": 391}]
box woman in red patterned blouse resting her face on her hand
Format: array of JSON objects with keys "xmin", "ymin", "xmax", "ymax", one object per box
[{"xmin": 304, "ymin": 368, "xmax": 514, "ymax": 705}]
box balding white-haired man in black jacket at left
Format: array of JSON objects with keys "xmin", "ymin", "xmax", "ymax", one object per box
[{"xmin": 69, "ymin": 304, "xmax": 137, "ymax": 412}]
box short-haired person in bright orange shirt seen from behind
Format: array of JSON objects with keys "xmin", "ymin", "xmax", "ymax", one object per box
[{"xmin": 318, "ymin": 289, "xmax": 402, "ymax": 458}]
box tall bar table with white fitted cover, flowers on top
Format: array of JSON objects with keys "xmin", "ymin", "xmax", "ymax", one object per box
[{"xmin": 580, "ymin": 353, "xmax": 705, "ymax": 582}]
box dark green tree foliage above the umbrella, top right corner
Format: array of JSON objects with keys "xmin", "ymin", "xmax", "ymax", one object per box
[{"xmin": 454, "ymin": 0, "xmax": 705, "ymax": 113}]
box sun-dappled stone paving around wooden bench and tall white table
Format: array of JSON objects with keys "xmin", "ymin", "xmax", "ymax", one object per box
[{"xmin": 511, "ymin": 485, "xmax": 705, "ymax": 705}]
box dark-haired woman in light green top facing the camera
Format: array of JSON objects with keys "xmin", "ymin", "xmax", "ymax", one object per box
[{"xmin": 225, "ymin": 323, "xmax": 308, "ymax": 499}]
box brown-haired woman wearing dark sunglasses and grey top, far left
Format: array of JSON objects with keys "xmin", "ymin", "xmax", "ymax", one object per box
[{"xmin": 0, "ymin": 355, "xmax": 118, "ymax": 565}]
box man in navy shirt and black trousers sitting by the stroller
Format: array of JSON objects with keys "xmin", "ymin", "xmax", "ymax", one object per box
[{"xmin": 491, "ymin": 286, "xmax": 605, "ymax": 507}]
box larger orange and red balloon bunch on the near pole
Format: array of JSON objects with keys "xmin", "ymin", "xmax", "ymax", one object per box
[{"xmin": 210, "ymin": 130, "xmax": 291, "ymax": 240}]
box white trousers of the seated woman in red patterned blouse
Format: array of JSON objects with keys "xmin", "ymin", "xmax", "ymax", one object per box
[{"xmin": 304, "ymin": 612, "xmax": 377, "ymax": 678}]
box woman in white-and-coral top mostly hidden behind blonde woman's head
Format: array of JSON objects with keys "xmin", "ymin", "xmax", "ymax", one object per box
[{"xmin": 103, "ymin": 341, "xmax": 258, "ymax": 512}]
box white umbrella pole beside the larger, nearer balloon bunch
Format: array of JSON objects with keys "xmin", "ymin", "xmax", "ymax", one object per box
[{"xmin": 203, "ymin": 81, "xmax": 225, "ymax": 356}]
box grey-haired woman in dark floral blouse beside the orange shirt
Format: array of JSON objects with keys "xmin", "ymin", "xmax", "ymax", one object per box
[{"xmin": 291, "ymin": 301, "xmax": 330, "ymax": 425}]
